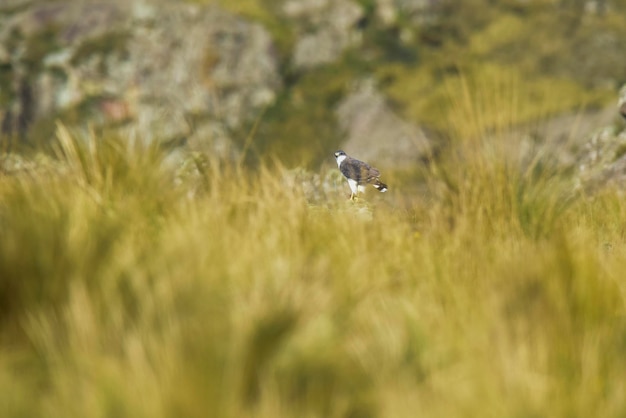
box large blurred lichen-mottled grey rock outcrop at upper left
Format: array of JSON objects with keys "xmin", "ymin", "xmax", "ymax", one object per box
[{"xmin": 0, "ymin": 1, "xmax": 281, "ymax": 154}]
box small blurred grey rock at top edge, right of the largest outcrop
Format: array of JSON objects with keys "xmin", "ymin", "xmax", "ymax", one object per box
[{"xmin": 283, "ymin": 0, "xmax": 364, "ymax": 69}]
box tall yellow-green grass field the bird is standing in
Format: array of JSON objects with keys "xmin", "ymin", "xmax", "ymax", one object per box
[{"xmin": 0, "ymin": 85, "xmax": 626, "ymax": 418}]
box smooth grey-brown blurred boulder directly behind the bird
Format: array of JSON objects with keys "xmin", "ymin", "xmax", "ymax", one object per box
[{"xmin": 336, "ymin": 80, "xmax": 431, "ymax": 168}]
